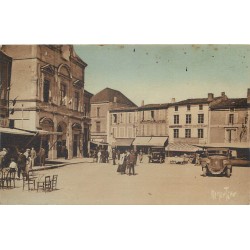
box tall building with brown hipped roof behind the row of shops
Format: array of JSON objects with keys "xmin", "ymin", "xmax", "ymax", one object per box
[{"xmin": 91, "ymin": 88, "xmax": 137, "ymax": 145}]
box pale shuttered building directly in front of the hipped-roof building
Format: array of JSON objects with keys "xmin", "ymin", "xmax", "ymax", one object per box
[{"xmin": 107, "ymin": 107, "xmax": 138, "ymax": 150}]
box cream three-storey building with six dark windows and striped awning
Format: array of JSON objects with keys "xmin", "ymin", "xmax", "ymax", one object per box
[{"xmin": 167, "ymin": 92, "xmax": 227, "ymax": 153}]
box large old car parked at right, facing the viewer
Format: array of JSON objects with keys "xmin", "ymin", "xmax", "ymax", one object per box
[{"xmin": 201, "ymin": 148, "xmax": 232, "ymax": 177}]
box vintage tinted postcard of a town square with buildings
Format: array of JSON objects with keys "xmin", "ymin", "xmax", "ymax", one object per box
[{"xmin": 0, "ymin": 44, "xmax": 250, "ymax": 205}]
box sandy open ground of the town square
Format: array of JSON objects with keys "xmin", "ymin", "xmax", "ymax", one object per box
[{"xmin": 0, "ymin": 162, "xmax": 250, "ymax": 205}]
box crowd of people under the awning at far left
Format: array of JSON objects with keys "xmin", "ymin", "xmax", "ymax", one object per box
[{"xmin": 0, "ymin": 147, "xmax": 45, "ymax": 179}]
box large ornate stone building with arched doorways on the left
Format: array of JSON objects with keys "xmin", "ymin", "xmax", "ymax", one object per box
[{"xmin": 2, "ymin": 45, "xmax": 89, "ymax": 158}]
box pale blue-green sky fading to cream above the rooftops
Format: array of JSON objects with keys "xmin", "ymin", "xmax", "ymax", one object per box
[{"xmin": 74, "ymin": 45, "xmax": 250, "ymax": 106}]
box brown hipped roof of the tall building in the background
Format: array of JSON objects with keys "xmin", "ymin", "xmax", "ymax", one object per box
[{"xmin": 90, "ymin": 88, "xmax": 137, "ymax": 107}]
